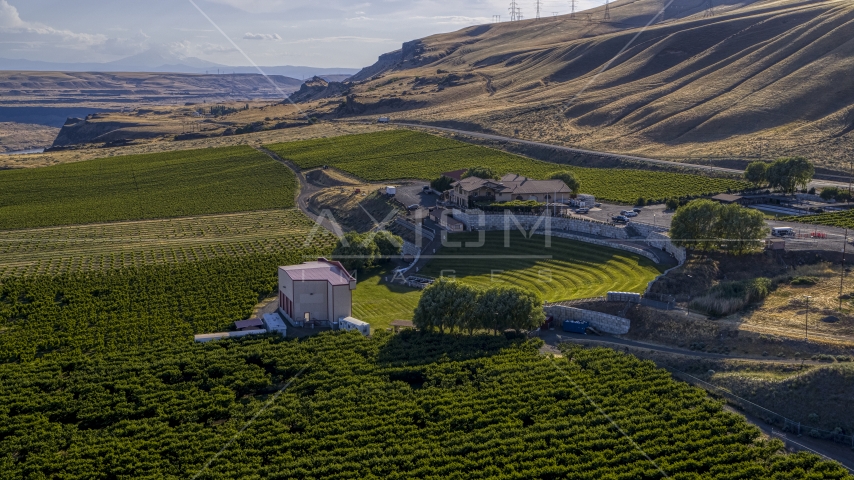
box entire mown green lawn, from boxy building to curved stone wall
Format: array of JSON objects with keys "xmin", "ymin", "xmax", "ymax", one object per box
[{"xmin": 353, "ymin": 232, "xmax": 663, "ymax": 329}]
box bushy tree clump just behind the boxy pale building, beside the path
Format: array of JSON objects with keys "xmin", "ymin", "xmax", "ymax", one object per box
[{"xmin": 332, "ymin": 230, "xmax": 403, "ymax": 270}]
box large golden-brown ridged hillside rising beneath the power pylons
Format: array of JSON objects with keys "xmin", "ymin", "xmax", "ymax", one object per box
[{"xmin": 337, "ymin": 0, "xmax": 854, "ymax": 164}]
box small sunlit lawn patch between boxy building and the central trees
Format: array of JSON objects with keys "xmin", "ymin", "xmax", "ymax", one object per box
[{"xmin": 353, "ymin": 268, "xmax": 421, "ymax": 330}]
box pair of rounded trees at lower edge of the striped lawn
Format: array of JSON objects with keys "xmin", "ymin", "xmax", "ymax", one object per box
[{"xmin": 413, "ymin": 278, "xmax": 545, "ymax": 334}]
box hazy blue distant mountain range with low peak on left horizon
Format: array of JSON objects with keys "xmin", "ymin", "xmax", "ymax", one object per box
[{"xmin": 0, "ymin": 50, "xmax": 359, "ymax": 80}]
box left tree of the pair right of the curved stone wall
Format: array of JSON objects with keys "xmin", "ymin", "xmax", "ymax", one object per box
[{"xmin": 670, "ymin": 199, "xmax": 723, "ymax": 250}]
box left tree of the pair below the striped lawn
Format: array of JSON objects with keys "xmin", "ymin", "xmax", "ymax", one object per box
[{"xmin": 412, "ymin": 278, "xmax": 478, "ymax": 333}]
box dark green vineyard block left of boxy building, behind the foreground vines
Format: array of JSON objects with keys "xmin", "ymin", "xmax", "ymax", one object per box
[{"xmin": 0, "ymin": 248, "xmax": 331, "ymax": 362}]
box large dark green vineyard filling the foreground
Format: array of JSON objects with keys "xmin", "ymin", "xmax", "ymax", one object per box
[{"xmin": 0, "ymin": 332, "xmax": 852, "ymax": 480}]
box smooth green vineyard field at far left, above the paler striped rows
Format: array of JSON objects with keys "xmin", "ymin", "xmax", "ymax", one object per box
[{"xmin": 0, "ymin": 146, "xmax": 297, "ymax": 230}]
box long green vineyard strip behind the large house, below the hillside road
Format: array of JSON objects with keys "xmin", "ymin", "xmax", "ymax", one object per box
[{"xmin": 267, "ymin": 130, "xmax": 748, "ymax": 204}]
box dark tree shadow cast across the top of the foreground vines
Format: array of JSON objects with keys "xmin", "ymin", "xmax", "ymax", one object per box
[{"xmin": 377, "ymin": 330, "xmax": 525, "ymax": 367}]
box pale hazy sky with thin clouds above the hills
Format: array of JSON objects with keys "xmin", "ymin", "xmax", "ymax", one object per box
[{"xmin": 0, "ymin": 0, "xmax": 604, "ymax": 68}]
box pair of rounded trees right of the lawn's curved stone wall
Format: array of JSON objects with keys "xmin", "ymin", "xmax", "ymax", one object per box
[{"xmin": 670, "ymin": 199, "xmax": 768, "ymax": 255}]
